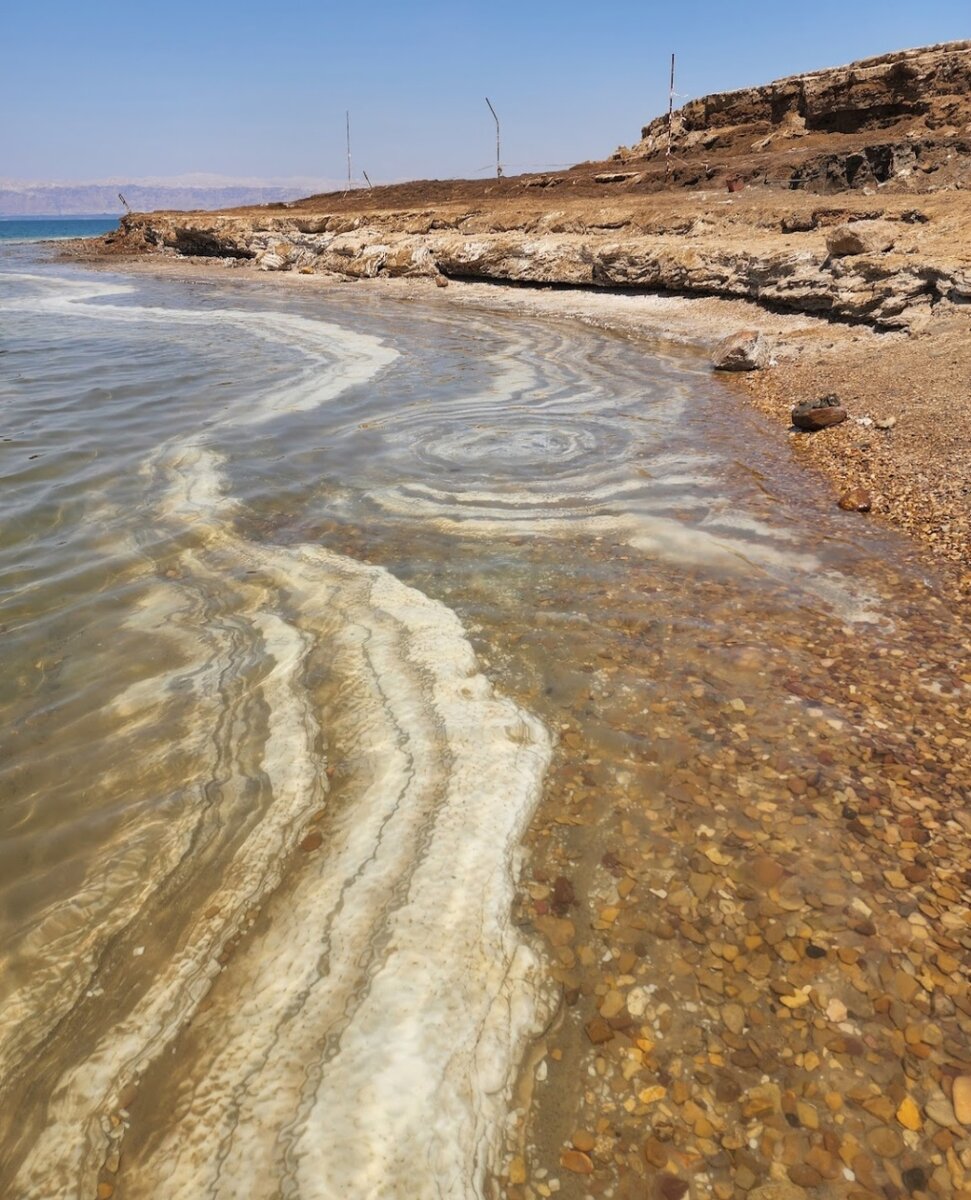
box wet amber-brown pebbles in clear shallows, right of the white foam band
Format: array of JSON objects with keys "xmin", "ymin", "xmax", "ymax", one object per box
[{"xmin": 304, "ymin": 504, "xmax": 971, "ymax": 1200}]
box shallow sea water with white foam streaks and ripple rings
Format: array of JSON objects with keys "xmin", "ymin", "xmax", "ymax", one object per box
[{"xmin": 0, "ymin": 246, "xmax": 960, "ymax": 1200}]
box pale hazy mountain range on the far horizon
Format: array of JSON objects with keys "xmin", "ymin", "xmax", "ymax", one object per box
[{"xmin": 0, "ymin": 175, "xmax": 342, "ymax": 217}]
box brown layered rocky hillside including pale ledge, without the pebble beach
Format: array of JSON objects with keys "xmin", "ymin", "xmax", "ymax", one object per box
[{"xmin": 96, "ymin": 42, "xmax": 971, "ymax": 329}]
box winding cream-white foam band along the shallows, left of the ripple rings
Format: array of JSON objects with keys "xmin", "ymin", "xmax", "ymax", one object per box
[{"xmin": 5, "ymin": 274, "xmax": 550, "ymax": 1198}]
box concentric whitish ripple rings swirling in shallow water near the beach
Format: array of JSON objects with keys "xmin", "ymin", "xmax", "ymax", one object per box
[{"xmin": 285, "ymin": 313, "xmax": 877, "ymax": 620}]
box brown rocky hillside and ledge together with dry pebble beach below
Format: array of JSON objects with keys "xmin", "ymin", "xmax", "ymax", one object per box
[{"xmin": 77, "ymin": 42, "xmax": 971, "ymax": 573}]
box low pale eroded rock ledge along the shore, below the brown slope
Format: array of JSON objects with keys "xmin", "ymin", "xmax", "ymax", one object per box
[{"xmin": 115, "ymin": 194, "xmax": 971, "ymax": 328}]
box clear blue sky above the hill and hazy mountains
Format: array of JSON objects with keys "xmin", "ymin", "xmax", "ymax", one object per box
[{"xmin": 0, "ymin": 0, "xmax": 971, "ymax": 181}]
